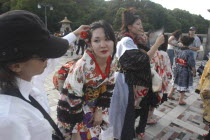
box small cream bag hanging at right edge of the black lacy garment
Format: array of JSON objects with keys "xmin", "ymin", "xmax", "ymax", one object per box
[{"xmin": 151, "ymin": 68, "xmax": 163, "ymax": 92}]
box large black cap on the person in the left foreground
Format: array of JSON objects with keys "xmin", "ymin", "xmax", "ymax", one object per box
[{"xmin": 0, "ymin": 10, "xmax": 69, "ymax": 62}]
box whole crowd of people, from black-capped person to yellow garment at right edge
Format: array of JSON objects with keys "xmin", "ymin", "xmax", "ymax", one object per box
[{"xmin": 0, "ymin": 8, "xmax": 210, "ymax": 140}]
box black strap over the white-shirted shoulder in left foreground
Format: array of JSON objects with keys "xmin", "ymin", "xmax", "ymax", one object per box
[{"xmin": 1, "ymin": 89, "xmax": 64, "ymax": 140}]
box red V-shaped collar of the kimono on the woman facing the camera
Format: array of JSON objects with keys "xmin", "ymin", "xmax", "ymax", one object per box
[{"xmin": 86, "ymin": 50, "xmax": 111, "ymax": 80}]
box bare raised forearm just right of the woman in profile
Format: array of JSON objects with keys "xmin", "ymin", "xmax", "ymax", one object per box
[{"xmin": 147, "ymin": 35, "xmax": 164, "ymax": 58}]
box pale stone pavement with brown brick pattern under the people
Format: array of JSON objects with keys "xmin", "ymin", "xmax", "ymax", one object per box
[{"xmin": 44, "ymin": 52, "xmax": 208, "ymax": 140}]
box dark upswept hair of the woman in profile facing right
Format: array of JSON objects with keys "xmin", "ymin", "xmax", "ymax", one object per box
[{"xmin": 121, "ymin": 8, "xmax": 140, "ymax": 32}]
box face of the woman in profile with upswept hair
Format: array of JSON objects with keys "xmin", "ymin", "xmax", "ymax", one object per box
[{"xmin": 128, "ymin": 19, "xmax": 144, "ymax": 37}]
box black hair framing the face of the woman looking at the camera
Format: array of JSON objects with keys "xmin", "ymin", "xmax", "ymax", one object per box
[{"xmin": 88, "ymin": 20, "xmax": 117, "ymax": 60}]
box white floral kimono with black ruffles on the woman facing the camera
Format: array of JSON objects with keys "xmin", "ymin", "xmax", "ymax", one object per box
[{"xmin": 57, "ymin": 50, "xmax": 115, "ymax": 140}]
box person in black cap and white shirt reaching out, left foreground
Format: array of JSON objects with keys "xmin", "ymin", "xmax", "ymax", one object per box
[{"xmin": 0, "ymin": 10, "xmax": 88, "ymax": 140}]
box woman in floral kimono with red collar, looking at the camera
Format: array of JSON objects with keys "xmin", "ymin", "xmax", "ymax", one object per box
[{"xmin": 57, "ymin": 21, "xmax": 116, "ymax": 140}]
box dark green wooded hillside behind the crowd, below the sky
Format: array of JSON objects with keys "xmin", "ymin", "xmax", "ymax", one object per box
[{"xmin": 0, "ymin": 0, "xmax": 209, "ymax": 33}]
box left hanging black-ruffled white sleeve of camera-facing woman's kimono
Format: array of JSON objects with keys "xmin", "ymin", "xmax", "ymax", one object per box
[{"xmin": 57, "ymin": 65, "xmax": 85, "ymax": 132}]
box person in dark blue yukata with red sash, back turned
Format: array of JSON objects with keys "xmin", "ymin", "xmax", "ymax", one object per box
[{"xmin": 168, "ymin": 36, "xmax": 196, "ymax": 105}]
